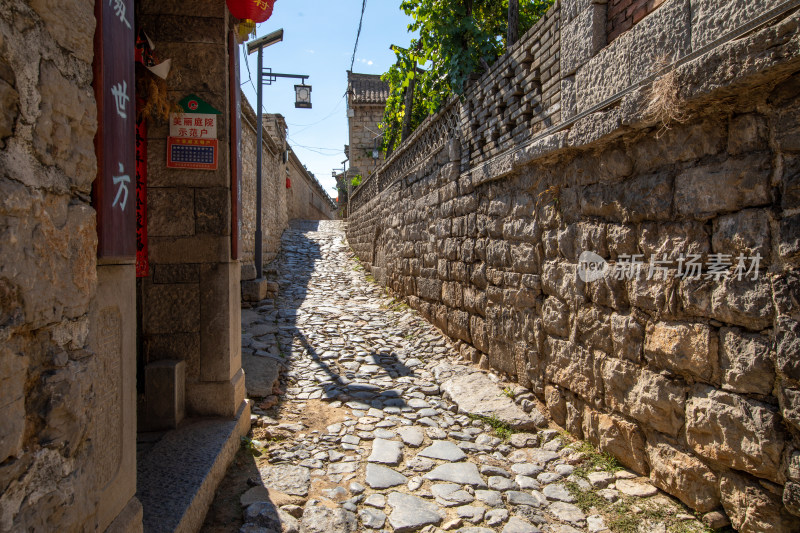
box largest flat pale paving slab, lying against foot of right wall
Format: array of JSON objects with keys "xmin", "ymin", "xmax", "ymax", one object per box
[{"xmin": 441, "ymin": 366, "xmax": 547, "ymax": 430}]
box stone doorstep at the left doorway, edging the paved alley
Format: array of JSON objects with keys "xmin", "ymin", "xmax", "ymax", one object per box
[{"xmin": 136, "ymin": 401, "xmax": 250, "ymax": 533}]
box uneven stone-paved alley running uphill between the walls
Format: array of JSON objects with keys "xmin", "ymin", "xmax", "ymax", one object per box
[{"xmin": 204, "ymin": 221, "xmax": 714, "ymax": 533}]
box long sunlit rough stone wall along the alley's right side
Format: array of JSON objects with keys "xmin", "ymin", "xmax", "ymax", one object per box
[{"xmin": 347, "ymin": 0, "xmax": 800, "ymax": 532}]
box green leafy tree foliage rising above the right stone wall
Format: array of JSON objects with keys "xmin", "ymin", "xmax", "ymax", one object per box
[{"xmin": 381, "ymin": 0, "xmax": 553, "ymax": 150}]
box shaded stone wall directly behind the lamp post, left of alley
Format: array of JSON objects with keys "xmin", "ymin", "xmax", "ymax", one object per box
[{"xmin": 239, "ymin": 94, "xmax": 289, "ymax": 279}]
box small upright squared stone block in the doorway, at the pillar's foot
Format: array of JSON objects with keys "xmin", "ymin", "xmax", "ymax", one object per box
[{"xmin": 145, "ymin": 359, "xmax": 186, "ymax": 430}]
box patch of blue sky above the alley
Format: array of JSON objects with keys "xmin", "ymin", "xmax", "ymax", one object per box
[{"xmin": 239, "ymin": 0, "xmax": 411, "ymax": 198}]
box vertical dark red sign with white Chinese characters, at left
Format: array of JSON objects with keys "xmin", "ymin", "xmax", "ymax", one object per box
[{"xmin": 92, "ymin": 0, "xmax": 136, "ymax": 259}]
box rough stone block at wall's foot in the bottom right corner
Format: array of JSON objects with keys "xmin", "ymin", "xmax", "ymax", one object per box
[{"xmin": 719, "ymin": 471, "xmax": 800, "ymax": 533}]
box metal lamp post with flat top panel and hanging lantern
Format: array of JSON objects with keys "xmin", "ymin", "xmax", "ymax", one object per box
[{"xmin": 247, "ymin": 28, "xmax": 311, "ymax": 279}]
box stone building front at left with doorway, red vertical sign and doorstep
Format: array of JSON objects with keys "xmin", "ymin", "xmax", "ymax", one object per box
[{"xmin": 0, "ymin": 0, "xmax": 310, "ymax": 532}]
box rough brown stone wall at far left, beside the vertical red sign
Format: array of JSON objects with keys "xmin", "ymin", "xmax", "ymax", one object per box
[{"xmin": 0, "ymin": 0, "xmax": 141, "ymax": 532}]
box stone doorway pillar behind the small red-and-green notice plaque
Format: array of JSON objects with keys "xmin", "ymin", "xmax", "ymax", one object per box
[{"xmin": 137, "ymin": 1, "xmax": 244, "ymax": 417}]
